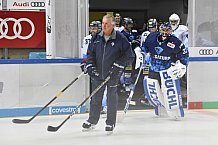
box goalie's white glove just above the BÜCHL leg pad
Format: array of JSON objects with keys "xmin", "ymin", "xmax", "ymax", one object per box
[{"xmin": 167, "ymin": 60, "xmax": 186, "ymax": 80}]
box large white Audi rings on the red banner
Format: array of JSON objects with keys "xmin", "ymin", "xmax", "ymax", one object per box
[{"xmin": 0, "ymin": 18, "xmax": 35, "ymax": 40}]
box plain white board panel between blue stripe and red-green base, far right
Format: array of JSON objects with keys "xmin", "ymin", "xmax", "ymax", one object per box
[{"xmin": 187, "ymin": 61, "xmax": 218, "ymax": 102}]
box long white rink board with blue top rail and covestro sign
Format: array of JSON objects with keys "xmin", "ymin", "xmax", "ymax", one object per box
[{"xmin": 0, "ymin": 59, "xmax": 89, "ymax": 117}]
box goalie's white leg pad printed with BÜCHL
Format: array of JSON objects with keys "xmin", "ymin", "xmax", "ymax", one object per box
[{"xmin": 160, "ymin": 70, "xmax": 184, "ymax": 118}]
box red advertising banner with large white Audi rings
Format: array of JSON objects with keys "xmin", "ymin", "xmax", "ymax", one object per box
[{"xmin": 0, "ymin": 11, "xmax": 46, "ymax": 48}]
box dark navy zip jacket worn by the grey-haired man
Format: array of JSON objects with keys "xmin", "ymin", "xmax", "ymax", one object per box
[{"xmin": 87, "ymin": 30, "xmax": 134, "ymax": 79}]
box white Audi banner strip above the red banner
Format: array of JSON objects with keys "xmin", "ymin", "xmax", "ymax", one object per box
[{"xmin": 7, "ymin": 0, "xmax": 45, "ymax": 10}]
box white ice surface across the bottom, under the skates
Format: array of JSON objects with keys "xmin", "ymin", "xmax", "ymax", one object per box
[{"xmin": 0, "ymin": 110, "xmax": 218, "ymax": 145}]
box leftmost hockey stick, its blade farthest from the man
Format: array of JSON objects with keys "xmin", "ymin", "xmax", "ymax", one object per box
[{"xmin": 12, "ymin": 72, "xmax": 84, "ymax": 124}]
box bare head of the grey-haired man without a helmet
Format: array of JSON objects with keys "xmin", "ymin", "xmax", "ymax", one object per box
[{"xmin": 102, "ymin": 17, "xmax": 114, "ymax": 36}]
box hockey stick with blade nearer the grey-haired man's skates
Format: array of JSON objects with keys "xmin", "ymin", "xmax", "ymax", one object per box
[{"xmin": 47, "ymin": 76, "xmax": 110, "ymax": 132}]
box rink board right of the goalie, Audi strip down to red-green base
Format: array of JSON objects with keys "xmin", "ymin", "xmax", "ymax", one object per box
[{"xmin": 187, "ymin": 47, "xmax": 218, "ymax": 109}]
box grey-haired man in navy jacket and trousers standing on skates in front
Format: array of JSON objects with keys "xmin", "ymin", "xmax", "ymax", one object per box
[{"xmin": 82, "ymin": 15, "xmax": 134, "ymax": 132}]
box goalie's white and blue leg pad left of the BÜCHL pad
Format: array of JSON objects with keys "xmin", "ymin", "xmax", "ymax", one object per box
[{"xmin": 143, "ymin": 76, "xmax": 165, "ymax": 107}]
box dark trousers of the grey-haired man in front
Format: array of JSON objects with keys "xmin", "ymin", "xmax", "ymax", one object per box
[{"xmin": 88, "ymin": 77, "xmax": 119, "ymax": 125}]
